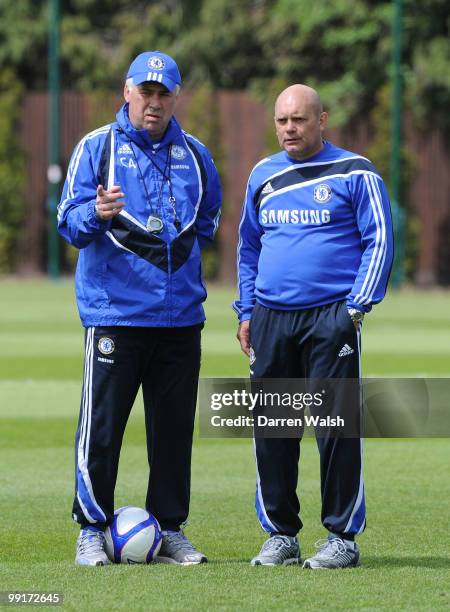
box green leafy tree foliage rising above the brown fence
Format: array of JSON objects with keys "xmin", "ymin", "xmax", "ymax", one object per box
[{"xmin": 0, "ymin": 0, "xmax": 450, "ymax": 126}]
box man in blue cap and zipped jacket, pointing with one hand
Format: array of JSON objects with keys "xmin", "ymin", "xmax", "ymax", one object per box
[{"xmin": 58, "ymin": 51, "xmax": 221, "ymax": 565}]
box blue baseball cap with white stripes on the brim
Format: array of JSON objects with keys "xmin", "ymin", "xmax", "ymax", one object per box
[{"xmin": 127, "ymin": 51, "xmax": 181, "ymax": 91}]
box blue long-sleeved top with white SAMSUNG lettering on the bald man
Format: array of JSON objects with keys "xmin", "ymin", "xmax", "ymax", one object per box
[{"xmin": 233, "ymin": 141, "xmax": 393, "ymax": 321}]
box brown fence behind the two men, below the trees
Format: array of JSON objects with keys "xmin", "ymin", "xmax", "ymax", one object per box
[{"xmin": 17, "ymin": 91, "xmax": 450, "ymax": 285}]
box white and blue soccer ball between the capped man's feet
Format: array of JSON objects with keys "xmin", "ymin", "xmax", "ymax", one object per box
[{"xmin": 105, "ymin": 506, "xmax": 162, "ymax": 563}]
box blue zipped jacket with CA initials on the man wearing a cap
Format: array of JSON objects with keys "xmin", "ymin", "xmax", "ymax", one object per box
[{"xmin": 58, "ymin": 104, "xmax": 221, "ymax": 327}]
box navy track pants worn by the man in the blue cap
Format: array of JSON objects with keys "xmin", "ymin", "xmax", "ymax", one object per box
[{"xmin": 73, "ymin": 324, "xmax": 203, "ymax": 530}]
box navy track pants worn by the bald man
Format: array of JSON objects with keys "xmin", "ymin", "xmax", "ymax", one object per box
[{"xmin": 250, "ymin": 301, "xmax": 365, "ymax": 537}]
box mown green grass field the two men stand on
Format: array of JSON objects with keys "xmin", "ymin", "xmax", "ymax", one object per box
[{"xmin": 0, "ymin": 280, "xmax": 450, "ymax": 610}]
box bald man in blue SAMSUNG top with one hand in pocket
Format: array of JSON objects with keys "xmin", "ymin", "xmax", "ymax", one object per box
[{"xmin": 233, "ymin": 85, "xmax": 393, "ymax": 569}]
